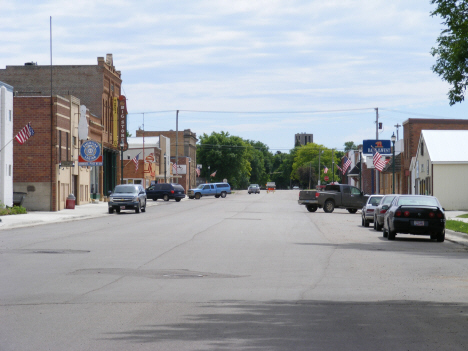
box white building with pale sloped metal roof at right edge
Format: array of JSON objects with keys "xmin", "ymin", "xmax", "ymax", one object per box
[{"xmin": 410, "ymin": 130, "xmax": 468, "ymax": 210}]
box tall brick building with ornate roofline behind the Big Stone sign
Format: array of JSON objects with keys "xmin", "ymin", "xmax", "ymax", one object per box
[{"xmin": 0, "ymin": 54, "xmax": 122, "ymax": 197}]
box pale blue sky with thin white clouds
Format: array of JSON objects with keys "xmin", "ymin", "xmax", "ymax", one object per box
[{"xmin": 0, "ymin": 0, "xmax": 468, "ymax": 152}]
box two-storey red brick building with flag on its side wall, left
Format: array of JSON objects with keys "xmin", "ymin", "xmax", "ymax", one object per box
[{"xmin": 13, "ymin": 96, "xmax": 96, "ymax": 211}]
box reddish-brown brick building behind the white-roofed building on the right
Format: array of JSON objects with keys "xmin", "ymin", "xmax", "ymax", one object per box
[{"xmin": 401, "ymin": 118, "xmax": 468, "ymax": 194}]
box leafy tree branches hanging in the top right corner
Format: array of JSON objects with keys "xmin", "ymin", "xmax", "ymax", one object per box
[{"xmin": 431, "ymin": 0, "xmax": 468, "ymax": 105}]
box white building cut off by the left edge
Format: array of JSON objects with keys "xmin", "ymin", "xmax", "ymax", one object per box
[{"xmin": 0, "ymin": 82, "xmax": 13, "ymax": 206}]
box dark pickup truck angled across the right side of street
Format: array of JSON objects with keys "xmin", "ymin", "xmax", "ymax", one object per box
[{"xmin": 298, "ymin": 184, "xmax": 369, "ymax": 213}]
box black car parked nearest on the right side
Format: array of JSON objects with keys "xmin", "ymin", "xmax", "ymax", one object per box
[{"xmin": 382, "ymin": 195, "xmax": 445, "ymax": 242}]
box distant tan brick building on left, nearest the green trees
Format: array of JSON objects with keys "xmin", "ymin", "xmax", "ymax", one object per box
[{"xmin": 136, "ymin": 129, "xmax": 198, "ymax": 190}]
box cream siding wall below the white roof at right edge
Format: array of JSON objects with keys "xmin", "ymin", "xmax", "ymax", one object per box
[{"xmin": 432, "ymin": 164, "xmax": 468, "ymax": 211}]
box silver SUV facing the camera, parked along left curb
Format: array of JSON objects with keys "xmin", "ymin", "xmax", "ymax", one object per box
[{"xmin": 107, "ymin": 184, "xmax": 146, "ymax": 213}]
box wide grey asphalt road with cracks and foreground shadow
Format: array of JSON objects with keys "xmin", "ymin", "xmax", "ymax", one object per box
[{"xmin": 0, "ymin": 191, "xmax": 468, "ymax": 351}]
